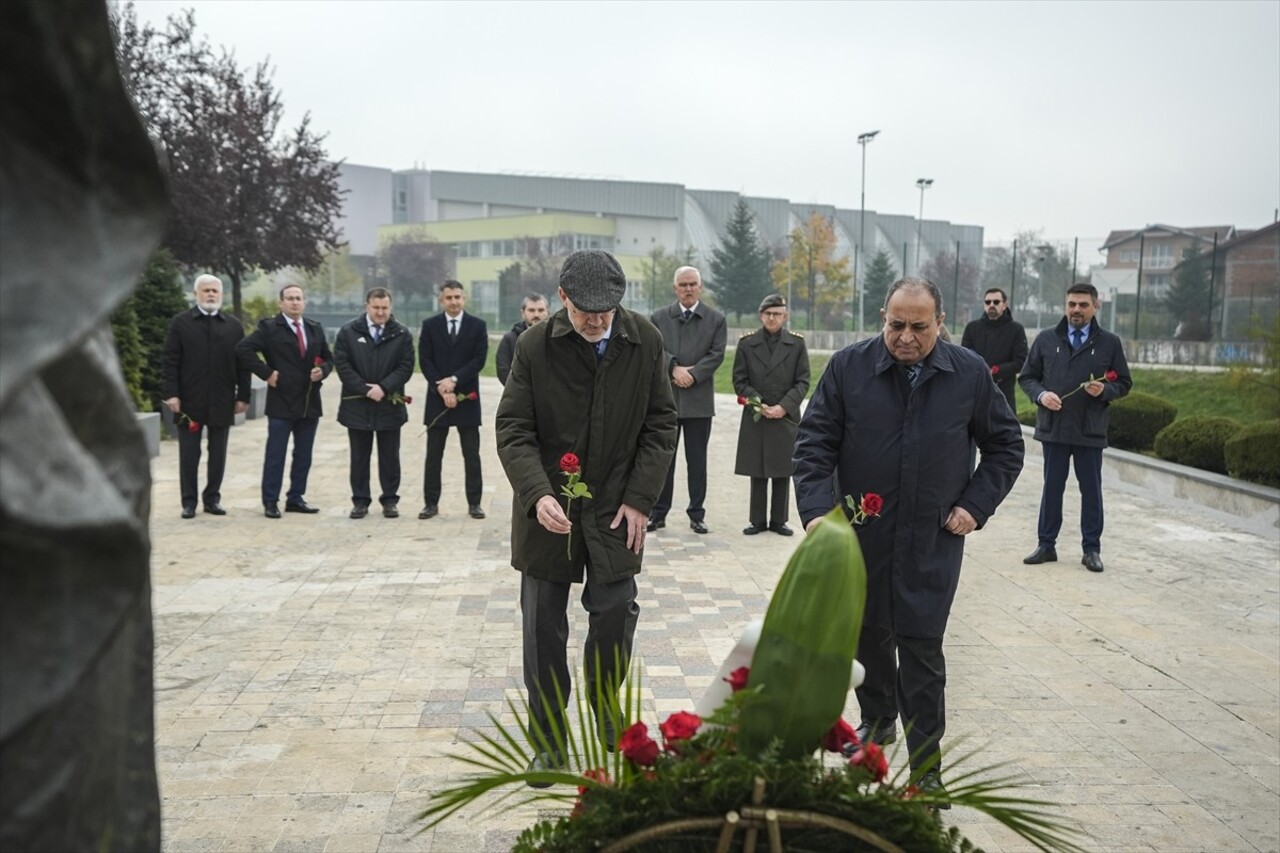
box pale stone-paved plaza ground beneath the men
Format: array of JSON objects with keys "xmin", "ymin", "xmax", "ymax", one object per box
[{"xmin": 151, "ymin": 377, "xmax": 1280, "ymax": 853}]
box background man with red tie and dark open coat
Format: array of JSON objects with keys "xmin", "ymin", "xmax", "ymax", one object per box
[{"xmin": 236, "ymin": 284, "xmax": 333, "ymax": 519}]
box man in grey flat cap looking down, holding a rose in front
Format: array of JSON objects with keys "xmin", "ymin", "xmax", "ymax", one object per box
[{"xmin": 497, "ymin": 250, "xmax": 676, "ymax": 788}]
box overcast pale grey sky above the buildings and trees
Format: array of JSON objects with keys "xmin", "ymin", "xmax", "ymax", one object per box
[{"xmin": 137, "ymin": 0, "xmax": 1280, "ymax": 241}]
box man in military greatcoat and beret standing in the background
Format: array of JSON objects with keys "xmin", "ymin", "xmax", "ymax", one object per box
[{"xmin": 733, "ymin": 293, "xmax": 809, "ymax": 537}]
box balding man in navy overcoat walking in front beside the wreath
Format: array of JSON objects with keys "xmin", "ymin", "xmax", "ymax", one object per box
[{"xmin": 795, "ymin": 278, "xmax": 1024, "ymax": 788}]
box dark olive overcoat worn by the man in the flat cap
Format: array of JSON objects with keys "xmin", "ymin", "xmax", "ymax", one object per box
[{"xmin": 495, "ymin": 307, "xmax": 676, "ymax": 583}]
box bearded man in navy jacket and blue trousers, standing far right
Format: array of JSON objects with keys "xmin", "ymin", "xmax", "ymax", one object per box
[{"xmin": 1018, "ymin": 284, "xmax": 1133, "ymax": 571}]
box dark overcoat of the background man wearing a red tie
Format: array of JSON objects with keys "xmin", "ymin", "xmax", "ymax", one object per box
[{"xmin": 236, "ymin": 314, "xmax": 333, "ymax": 420}]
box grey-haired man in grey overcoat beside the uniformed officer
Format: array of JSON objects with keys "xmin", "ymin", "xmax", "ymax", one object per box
[{"xmin": 648, "ymin": 266, "xmax": 727, "ymax": 533}]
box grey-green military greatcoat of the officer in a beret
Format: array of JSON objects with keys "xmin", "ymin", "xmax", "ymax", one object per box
[{"xmin": 733, "ymin": 329, "xmax": 809, "ymax": 478}]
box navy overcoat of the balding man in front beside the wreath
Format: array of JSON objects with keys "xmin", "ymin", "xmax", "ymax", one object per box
[{"xmin": 795, "ymin": 336, "xmax": 1024, "ymax": 638}]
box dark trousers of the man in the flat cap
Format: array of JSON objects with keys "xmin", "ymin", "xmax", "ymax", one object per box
[{"xmin": 520, "ymin": 566, "xmax": 640, "ymax": 752}]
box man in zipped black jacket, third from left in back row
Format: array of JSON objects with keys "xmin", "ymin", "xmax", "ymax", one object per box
[{"xmin": 333, "ymin": 287, "xmax": 413, "ymax": 519}]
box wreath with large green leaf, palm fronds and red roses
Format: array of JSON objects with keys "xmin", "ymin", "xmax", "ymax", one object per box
[{"xmin": 421, "ymin": 508, "xmax": 1080, "ymax": 853}]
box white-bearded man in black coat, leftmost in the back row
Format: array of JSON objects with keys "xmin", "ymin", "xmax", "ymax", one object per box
[{"xmin": 164, "ymin": 275, "xmax": 250, "ymax": 519}]
